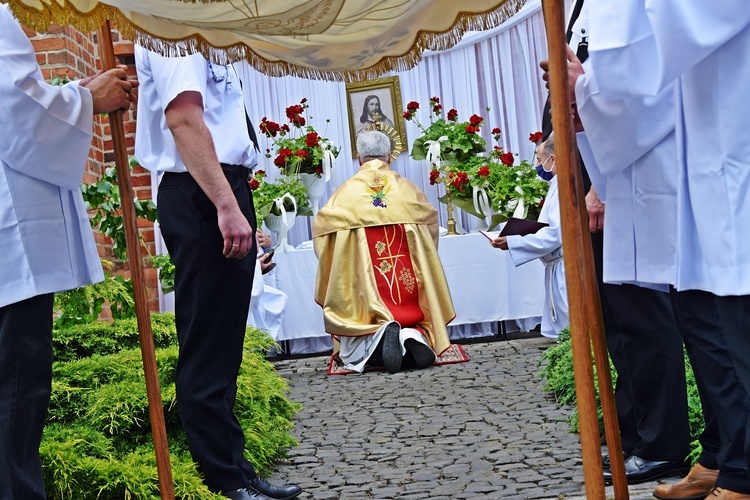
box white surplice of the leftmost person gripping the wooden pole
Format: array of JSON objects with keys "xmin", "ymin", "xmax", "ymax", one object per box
[{"xmin": 0, "ymin": 5, "xmax": 104, "ymax": 307}]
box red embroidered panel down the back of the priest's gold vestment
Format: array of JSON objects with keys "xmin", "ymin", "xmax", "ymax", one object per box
[{"xmin": 365, "ymin": 224, "xmax": 434, "ymax": 338}]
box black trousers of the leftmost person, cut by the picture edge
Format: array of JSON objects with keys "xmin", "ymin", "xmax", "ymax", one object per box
[{"xmin": 0, "ymin": 293, "xmax": 53, "ymax": 500}]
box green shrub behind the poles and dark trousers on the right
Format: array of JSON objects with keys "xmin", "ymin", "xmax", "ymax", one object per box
[{"xmin": 539, "ymin": 328, "xmax": 704, "ymax": 462}]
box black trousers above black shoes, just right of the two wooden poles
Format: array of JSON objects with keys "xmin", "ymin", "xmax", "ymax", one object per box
[{"xmin": 591, "ymin": 233, "xmax": 690, "ymax": 460}]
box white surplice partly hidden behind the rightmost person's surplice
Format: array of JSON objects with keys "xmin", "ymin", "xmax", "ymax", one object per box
[{"xmin": 573, "ymin": 1, "xmax": 680, "ymax": 290}]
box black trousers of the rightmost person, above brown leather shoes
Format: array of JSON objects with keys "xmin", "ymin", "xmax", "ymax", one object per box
[{"xmin": 671, "ymin": 290, "xmax": 750, "ymax": 494}]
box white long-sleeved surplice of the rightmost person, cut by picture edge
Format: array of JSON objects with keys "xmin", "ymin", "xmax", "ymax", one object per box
[{"xmin": 589, "ymin": 0, "xmax": 750, "ymax": 295}]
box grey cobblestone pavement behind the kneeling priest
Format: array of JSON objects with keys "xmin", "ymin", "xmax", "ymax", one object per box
[{"xmin": 270, "ymin": 337, "xmax": 676, "ymax": 500}]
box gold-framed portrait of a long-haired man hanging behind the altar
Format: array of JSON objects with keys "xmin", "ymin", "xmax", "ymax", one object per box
[{"xmin": 346, "ymin": 76, "xmax": 407, "ymax": 159}]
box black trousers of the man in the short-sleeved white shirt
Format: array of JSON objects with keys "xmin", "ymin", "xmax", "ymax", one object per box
[{"xmin": 157, "ymin": 169, "xmax": 257, "ymax": 492}]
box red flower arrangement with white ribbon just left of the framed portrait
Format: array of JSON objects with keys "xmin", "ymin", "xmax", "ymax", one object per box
[{"xmin": 258, "ymin": 98, "xmax": 339, "ymax": 180}]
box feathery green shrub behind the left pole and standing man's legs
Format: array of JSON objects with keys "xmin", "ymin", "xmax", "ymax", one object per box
[{"xmin": 40, "ymin": 315, "xmax": 300, "ymax": 500}]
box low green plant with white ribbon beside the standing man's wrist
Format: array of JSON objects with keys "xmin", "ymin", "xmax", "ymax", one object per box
[{"xmin": 247, "ymin": 170, "xmax": 312, "ymax": 222}]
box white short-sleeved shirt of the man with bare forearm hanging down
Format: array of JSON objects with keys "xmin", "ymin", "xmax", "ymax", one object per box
[{"xmin": 135, "ymin": 46, "xmax": 257, "ymax": 172}]
